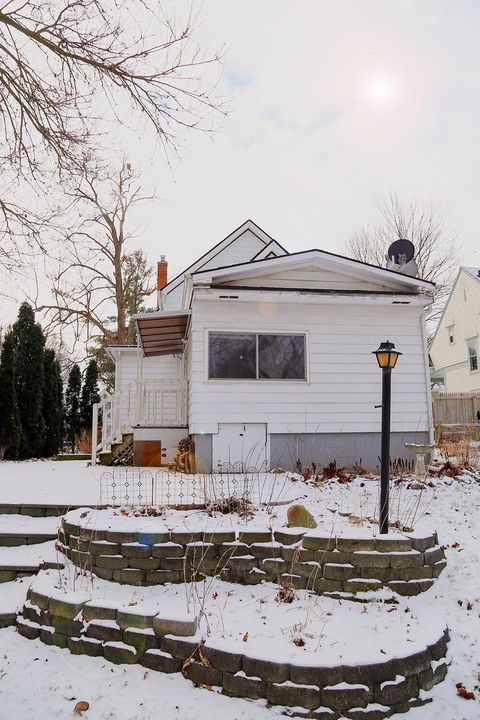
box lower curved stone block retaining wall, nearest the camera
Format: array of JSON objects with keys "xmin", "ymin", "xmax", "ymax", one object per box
[{"xmin": 17, "ymin": 588, "xmax": 449, "ymax": 720}]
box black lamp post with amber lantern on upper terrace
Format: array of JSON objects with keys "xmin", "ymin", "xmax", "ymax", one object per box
[{"xmin": 373, "ymin": 340, "xmax": 402, "ymax": 535}]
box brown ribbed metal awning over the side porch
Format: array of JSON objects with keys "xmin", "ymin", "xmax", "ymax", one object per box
[{"xmin": 135, "ymin": 310, "xmax": 191, "ymax": 357}]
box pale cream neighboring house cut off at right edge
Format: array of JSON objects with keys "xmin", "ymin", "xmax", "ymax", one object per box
[{"xmin": 430, "ymin": 267, "xmax": 480, "ymax": 393}]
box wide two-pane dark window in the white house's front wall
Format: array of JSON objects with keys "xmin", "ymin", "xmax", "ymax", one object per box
[{"xmin": 208, "ymin": 332, "xmax": 307, "ymax": 380}]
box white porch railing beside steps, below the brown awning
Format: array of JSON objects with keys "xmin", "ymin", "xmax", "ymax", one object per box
[{"xmin": 92, "ymin": 379, "xmax": 187, "ymax": 462}]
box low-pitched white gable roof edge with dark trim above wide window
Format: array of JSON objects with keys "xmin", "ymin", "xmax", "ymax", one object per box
[{"xmin": 192, "ymin": 248, "xmax": 435, "ymax": 291}]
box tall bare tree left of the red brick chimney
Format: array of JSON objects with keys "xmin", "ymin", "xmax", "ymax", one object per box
[{"xmin": 35, "ymin": 161, "xmax": 154, "ymax": 346}]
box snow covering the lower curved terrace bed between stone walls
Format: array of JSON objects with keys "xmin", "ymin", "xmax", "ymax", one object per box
[{"xmin": 27, "ymin": 561, "xmax": 446, "ymax": 666}]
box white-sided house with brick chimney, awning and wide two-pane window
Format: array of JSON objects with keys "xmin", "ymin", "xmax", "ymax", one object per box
[{"xmin": 96, "ymin": 220, "xmax": 433, "ymax": 471}]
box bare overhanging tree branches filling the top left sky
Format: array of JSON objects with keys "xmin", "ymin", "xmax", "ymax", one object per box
[{"xmin": 0, "ymin": 0, "xmax": 222, "ymax": 264}]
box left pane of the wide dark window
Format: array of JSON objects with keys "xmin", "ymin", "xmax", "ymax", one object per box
[{"xmin": 208, "ymin": 333, "xmax": 256, "ymax": 379}]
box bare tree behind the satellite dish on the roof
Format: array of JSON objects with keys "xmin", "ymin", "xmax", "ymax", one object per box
[{"xmin": 345, "ymin": 194, "xmax": 458, "ymax": 320}]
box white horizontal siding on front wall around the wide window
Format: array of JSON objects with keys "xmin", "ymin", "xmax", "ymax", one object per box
[{"xmin": 189, "ymin": 299, "xmax": 430, "ymax": 433}]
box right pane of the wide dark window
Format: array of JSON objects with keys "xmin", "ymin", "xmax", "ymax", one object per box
[{"xmin": 258, "ymin": 335, "xmax": 305, "ymax": 380}]
